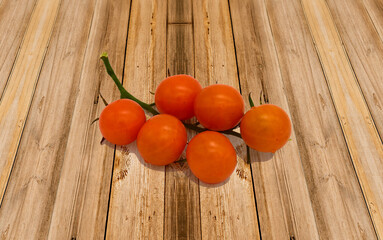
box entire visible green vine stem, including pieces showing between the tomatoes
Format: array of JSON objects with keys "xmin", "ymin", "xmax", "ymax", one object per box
[{"xmin": 100, "ymin": 52, "xmax": 242, "ymax": 138}]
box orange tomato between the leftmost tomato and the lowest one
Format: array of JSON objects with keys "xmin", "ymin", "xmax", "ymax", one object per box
[{"xmin": 137, "ymin": 114, "xmax": 187, "ymax": 166}]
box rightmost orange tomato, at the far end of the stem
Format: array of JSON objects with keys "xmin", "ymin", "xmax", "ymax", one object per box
[{"xmin": 241, "ymin": 104, "xmax": 291, "ymax": 153}]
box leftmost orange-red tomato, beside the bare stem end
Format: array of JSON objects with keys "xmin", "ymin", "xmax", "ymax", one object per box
[{"xmin": 99, "ymin": 99, "xmax": 146, "ymax": 145}]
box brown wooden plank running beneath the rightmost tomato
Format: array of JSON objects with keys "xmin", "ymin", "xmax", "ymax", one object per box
[{"xmin": 230, "ymin": 0, "xmax": 319, "ymax": 239}]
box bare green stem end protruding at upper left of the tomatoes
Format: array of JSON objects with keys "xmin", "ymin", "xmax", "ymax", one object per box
[{"xmin": 100, "ymin": 52, "xmax": 159, "ymax": 115}]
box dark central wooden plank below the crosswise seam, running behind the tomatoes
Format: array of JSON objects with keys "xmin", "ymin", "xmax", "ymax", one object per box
[{"xmin": 164, "ymin": 23, "xmax": 201, "ymax": 239}]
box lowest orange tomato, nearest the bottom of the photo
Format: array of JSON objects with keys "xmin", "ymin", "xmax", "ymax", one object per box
[{"xmin": 186, "ymin": 131, "xmax": 237, "ymax": 184}]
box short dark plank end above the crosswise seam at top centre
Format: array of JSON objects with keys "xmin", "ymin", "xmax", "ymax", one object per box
[{"xmin": 168, "ymin": 0, "xmax": 193, "ymax": 24}]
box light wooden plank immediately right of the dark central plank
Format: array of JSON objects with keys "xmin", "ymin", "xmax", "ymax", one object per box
[{"xmin": 193, "ymin": 1, "xmax": 260, "ymax": 239}]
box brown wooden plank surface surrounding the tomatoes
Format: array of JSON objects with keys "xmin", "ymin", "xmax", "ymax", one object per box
[{"xmin": 0, "ymin": 0, "xmax": 383, "ymax": 240}]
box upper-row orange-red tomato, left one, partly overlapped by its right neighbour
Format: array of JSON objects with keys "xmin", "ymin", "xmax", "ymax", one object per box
[{"xmin": 155, "ymin": 75, "xmax": 202, "ymax": 120}]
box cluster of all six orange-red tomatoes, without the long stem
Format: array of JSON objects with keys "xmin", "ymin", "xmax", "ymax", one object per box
[{"xmin": 99, "ymin": 75, "xmax": 291, "ymax": 184}]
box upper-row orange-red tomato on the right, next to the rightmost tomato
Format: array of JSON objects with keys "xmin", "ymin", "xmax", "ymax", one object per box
[{"xmin": 194, "ymin": 84, "xmax": 244, "ymax": 131}]
